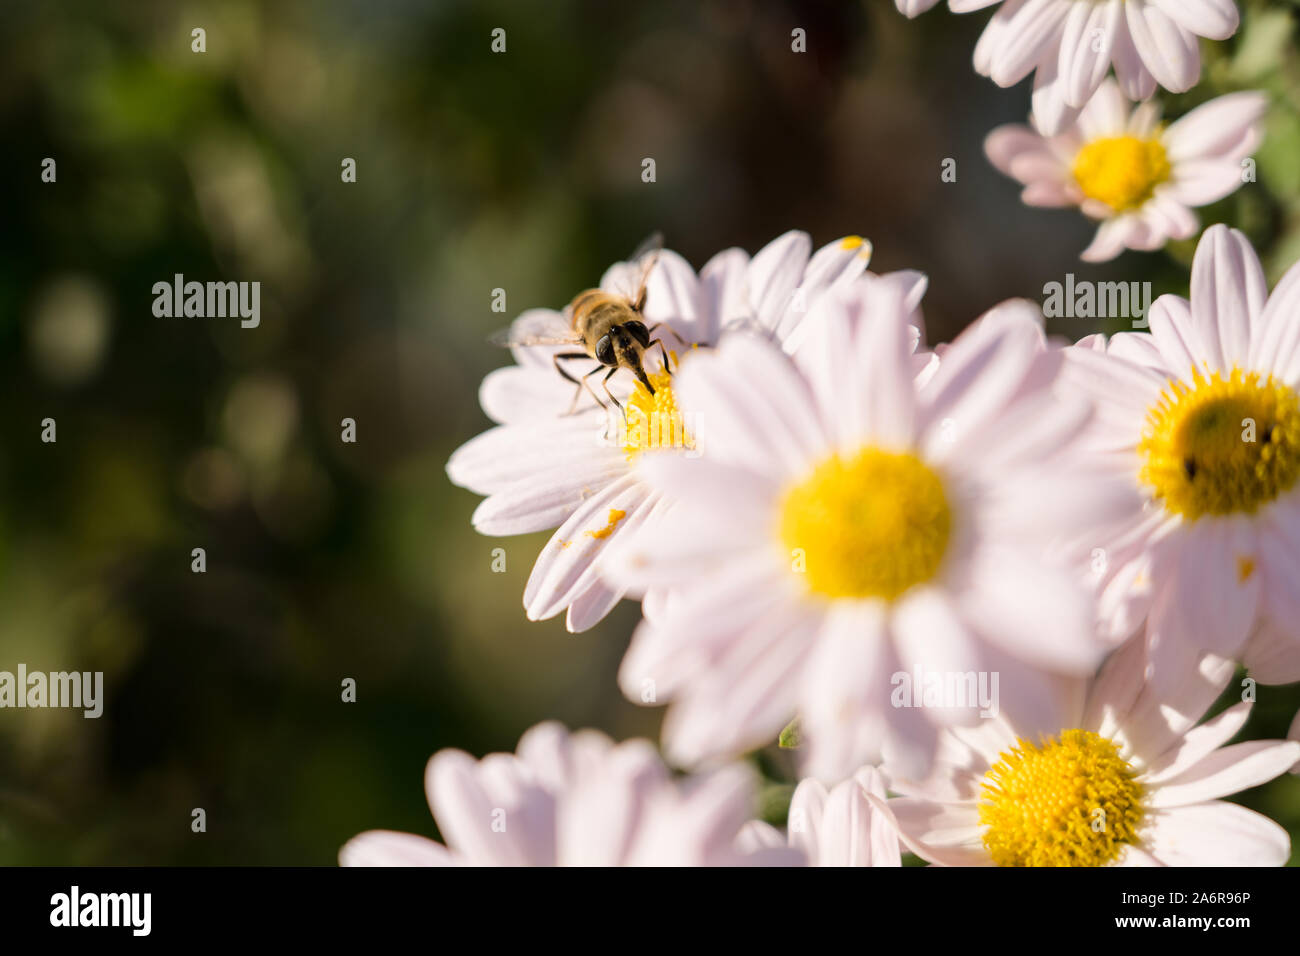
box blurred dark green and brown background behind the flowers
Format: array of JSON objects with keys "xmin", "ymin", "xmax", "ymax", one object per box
[{"xmin": 0, "ymin": 0, "xmax": 1300, "ymax": 865}]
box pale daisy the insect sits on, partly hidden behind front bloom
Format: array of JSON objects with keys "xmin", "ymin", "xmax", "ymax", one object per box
[{"xmin": 447, "ymin": 232, "xmax": 926, "ymax": 631}]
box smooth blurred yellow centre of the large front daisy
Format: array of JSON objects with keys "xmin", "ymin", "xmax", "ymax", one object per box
[{"xmin": 780, "ymin": 449, "xmax": 952, "ymax": 601}]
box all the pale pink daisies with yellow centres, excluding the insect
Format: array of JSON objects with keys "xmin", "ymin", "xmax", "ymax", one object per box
[{"xmin": 341, "ymin": 7, "xmax": 1300, "ymax": 866}]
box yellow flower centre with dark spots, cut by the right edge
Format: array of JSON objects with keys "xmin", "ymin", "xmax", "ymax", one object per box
[{"xmin": 1138, "ymin": 368, "xmax": 1300, "ymax": 520}]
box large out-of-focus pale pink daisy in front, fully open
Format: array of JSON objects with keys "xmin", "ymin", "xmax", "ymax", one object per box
[{"xmin": 607, "ymin": 285, "xmax": 1126, "ymax": 780}]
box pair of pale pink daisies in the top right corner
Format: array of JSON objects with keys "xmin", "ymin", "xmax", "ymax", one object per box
[{"xmin": 896, "ymin": 0, "xmax": 1268, "ymax": 261}]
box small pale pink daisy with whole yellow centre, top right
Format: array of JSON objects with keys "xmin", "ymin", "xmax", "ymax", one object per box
[{"xmin": 984, "ymin": 79, "xmax": 1268, "ymax": 263}]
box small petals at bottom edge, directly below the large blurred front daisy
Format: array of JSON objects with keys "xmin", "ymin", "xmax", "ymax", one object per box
[{"xmin": 741, "ymin": 767, "xmax": 902, "ymax": 866}]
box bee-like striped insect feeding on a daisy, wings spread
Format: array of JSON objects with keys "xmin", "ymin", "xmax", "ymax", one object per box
[{"xmin": 489, "ymin": 233, "xmax": 676, "ymax": 415}]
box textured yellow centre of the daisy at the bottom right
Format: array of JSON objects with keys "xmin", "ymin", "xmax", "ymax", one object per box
[{"xmin": 979, "ymin": 730, "xmax": 1143, "ymax": 866}]
